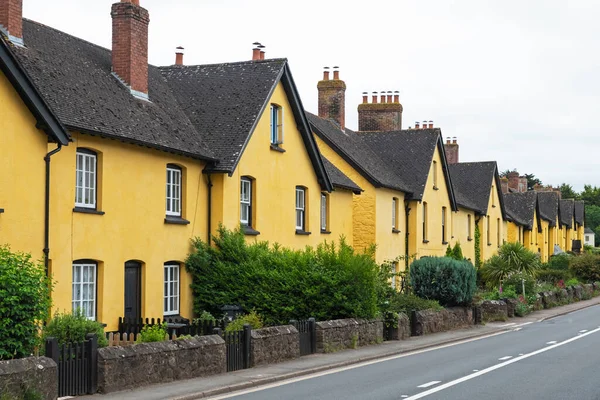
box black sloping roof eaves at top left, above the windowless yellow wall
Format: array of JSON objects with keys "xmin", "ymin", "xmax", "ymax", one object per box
[{"xmin": 0, "ymin": 33, "xmax": 70, "ymax": 146}]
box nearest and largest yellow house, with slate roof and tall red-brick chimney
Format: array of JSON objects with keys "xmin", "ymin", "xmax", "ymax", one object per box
[{"xmin": 0, "ymin": 0, "xmax": 361, "ymax": 330}]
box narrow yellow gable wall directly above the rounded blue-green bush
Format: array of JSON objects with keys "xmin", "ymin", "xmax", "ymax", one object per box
[{"xmin": 408, "ymin": 147, "xmax": 452, "ymax": 258}]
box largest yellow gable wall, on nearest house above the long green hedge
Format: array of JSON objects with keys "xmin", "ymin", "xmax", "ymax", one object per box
[{"xmin": 212, "ymin": 84, "xmax": 353, "ymax": 249}]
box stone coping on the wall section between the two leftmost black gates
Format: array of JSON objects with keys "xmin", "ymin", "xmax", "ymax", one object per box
[{"xmin": 98, "ymin": 335, "xmax": 225, "ymax": 360}]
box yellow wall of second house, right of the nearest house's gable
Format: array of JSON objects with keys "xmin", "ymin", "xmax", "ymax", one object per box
[{"xmin": 315, "ymin": 132, "xmax": 406, "ymax": 269}]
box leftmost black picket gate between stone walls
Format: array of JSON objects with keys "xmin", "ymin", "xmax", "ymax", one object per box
[{"xmin": 46, "ymin": 334, "xmax": 98, "ymax": 397}]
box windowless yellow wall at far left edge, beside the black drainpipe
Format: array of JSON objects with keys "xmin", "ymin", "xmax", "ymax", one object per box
[{"xmin": 0, "ymin": 72, "xmax": 48, "ymax": 260}]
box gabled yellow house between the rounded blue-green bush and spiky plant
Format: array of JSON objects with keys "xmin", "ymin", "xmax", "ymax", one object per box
[{"xmin": 449, "ymin": 161, "xmax": 507, "ymax": 263}]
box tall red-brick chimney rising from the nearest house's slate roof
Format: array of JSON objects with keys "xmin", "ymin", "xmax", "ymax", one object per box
[{"xmin": 111, "ymin": 0, "xmax": 150, "ymax": 100}]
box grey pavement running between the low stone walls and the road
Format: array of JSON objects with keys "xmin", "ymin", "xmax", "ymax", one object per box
[{"xmin": 86, "ymin": 297, "xmax": 600, "ymax": 400}]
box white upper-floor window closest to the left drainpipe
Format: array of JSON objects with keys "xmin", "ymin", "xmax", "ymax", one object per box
[{"xmin": 75, "ymin": 150, "xmax": 98, "ymax": 209}]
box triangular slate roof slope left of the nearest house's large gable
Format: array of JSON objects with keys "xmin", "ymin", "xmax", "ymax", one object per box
[{"xmin": 160, "ymin": 59, "xmax": 286, "ymax": 172}]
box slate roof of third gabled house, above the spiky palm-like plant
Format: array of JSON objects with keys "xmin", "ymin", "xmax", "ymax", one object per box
[{"xmin": 448, "ymin": 161, "xmax": 502, "ymax": 215}]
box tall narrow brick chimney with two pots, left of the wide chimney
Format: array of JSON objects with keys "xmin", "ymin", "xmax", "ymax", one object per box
[{"xmin": 317, "ymin": 67, "xmax": 346, "ymax": 129}]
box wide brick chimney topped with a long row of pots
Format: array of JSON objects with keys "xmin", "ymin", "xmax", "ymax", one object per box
[{"xmin": 358, "ymin": 91, "xmax": 404, "ymax": 132}]
